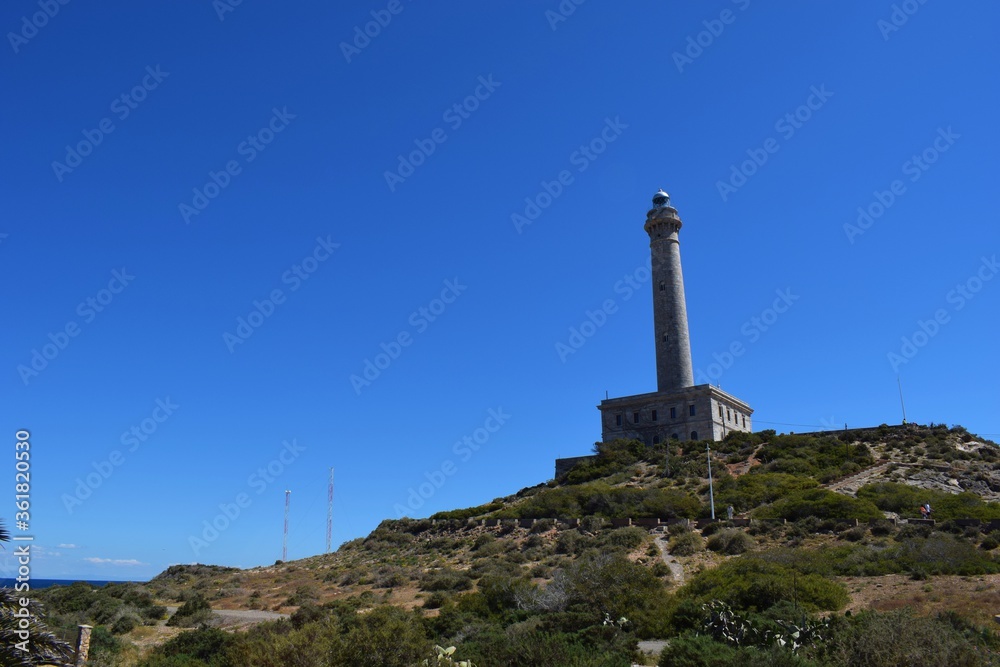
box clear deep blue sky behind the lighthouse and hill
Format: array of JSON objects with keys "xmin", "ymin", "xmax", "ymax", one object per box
[{"xmin": 0, "ymin": 0, "xmax": 1000, "ymax": 579}]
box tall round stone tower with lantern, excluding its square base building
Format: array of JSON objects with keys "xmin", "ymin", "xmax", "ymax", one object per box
[{"xmin": 646, "ymin": 190, "xmax": 694, "ymax": 392}]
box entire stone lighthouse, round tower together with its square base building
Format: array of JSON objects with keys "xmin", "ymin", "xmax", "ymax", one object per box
[{"xmin": 597, "ymin": 190, "xmax": 753, "ymax": 445}]
